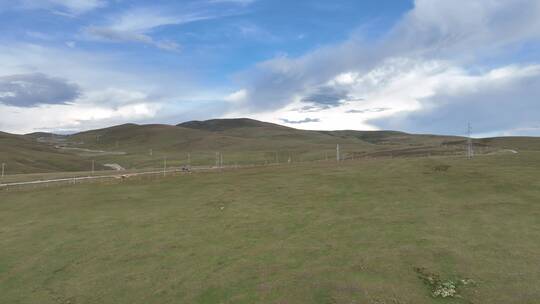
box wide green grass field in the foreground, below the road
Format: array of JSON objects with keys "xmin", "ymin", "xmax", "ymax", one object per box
[{"xmin": 0, "ymin": 152, "xmax": 540, "ymax": 304}]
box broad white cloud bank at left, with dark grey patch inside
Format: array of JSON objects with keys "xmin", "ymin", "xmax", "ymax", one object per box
[{"xmin": 0, "ymin": 43, "xmax": 208, "ymax": 133}]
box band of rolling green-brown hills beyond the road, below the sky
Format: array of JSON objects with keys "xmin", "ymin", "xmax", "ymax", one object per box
[{"xmin": 0, "ymin": 118, "xmax": 540, "ymax": 174}]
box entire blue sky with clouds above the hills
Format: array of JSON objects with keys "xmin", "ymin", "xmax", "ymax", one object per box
[{"xmin": 0, "ymin": 0, "xmax": 540, "ymax": 136}]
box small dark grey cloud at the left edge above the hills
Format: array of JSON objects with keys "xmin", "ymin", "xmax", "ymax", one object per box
[{"xmin": 0, "ymin": 73, "xmax": 80, "ymax": 107}]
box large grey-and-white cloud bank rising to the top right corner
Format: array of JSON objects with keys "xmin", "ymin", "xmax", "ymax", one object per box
[{"xmin": 230, "ymin": 0, "xmax": 540, "ymax": 134}]
